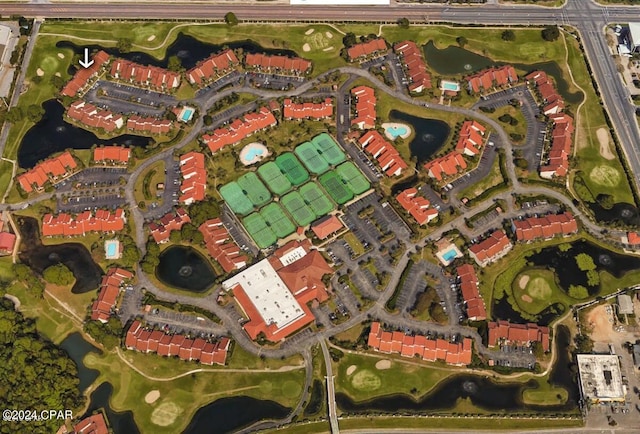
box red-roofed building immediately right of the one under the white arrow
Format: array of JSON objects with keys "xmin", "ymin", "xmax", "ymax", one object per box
[{"xmin": 110, "ymin": 59, "xmax": 180, "ymax": 91}]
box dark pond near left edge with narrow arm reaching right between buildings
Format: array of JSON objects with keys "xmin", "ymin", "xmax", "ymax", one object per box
[{"xmin": 18, "ymin": 99, "xmax": 152, "ymax": 169}]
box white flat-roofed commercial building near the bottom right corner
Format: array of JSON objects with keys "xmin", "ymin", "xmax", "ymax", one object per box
[{"xmin": 577, "ymin": 354, "xmax": 626, "ymax": 404}]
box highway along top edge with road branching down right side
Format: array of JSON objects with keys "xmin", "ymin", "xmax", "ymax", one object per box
[{"xmin": 0, "ymin": 0, "xmax": 640, "ymax": 194}]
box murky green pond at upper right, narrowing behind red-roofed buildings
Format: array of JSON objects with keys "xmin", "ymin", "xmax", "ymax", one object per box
[{"xmin": 424, "ymin": 41, "xmax": 584, "ymax": 104}]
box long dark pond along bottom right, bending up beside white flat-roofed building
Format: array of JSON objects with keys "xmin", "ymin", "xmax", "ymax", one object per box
[{"xmin": 336, "ymin": 327, "xmax": 578, "ymax": 413}]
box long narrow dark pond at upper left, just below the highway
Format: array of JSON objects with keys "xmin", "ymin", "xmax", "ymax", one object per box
[{"xmin": 56, "ymin": 33, "xmax": 298, "ymax": 73}]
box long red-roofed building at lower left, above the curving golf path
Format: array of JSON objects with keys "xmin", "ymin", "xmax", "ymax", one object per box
[{"xmin": 124, "ymin": 321, "xmax": 231, "ymax": 365}]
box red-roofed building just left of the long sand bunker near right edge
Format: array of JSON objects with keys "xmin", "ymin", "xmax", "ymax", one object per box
[{"xmin": 540, "ymin": 113, "xmax": 574, "ymax": 179}]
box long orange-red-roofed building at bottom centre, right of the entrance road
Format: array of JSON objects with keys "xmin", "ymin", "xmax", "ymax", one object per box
[{"xmin": 367, "ymin": 322, "xmax": 473, "ymax": 366}]
